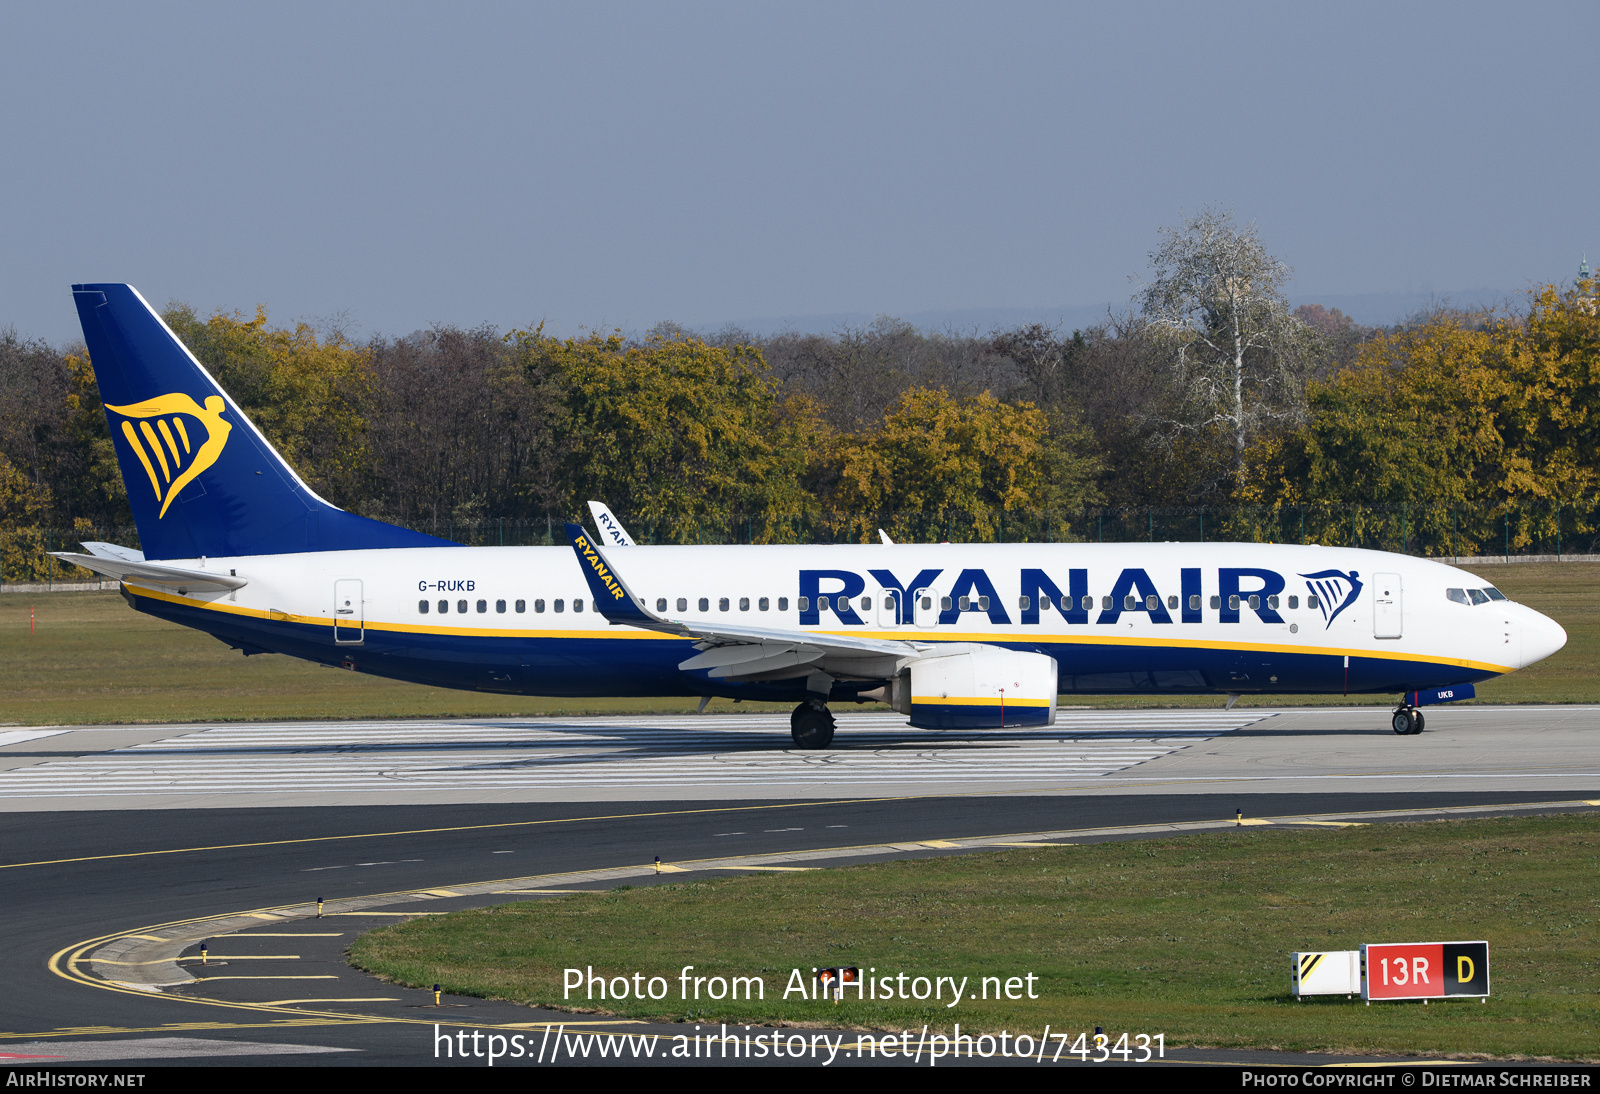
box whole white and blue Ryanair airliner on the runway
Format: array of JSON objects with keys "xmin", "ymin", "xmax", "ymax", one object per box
[{"xmin": 59, "ymin": 285, "xmax": 1566, "ymax": 749}]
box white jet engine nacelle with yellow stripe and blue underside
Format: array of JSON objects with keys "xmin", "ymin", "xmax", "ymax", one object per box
[{"xmin": 896, "ymin": 643, "xmax": 1056, "ymax": 729}]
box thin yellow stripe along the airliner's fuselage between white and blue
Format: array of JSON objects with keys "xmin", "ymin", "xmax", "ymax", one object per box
[{"xmin": 123, "ymin": 588, "xmax": 1515, "ymax": 674}]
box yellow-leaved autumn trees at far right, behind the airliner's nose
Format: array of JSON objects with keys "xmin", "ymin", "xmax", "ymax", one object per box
[{"xmin": 1243, "ymin": 286, "xmax": 1600, "ymax": 553}]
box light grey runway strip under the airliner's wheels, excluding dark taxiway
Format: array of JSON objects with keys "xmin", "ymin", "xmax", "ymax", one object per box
[{"xmin": 0, "ymin": 707, "xmax": 1600, "ymax": 809}]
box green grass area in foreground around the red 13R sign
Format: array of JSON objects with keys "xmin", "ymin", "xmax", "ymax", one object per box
[{"xmin": 352, "ymin": 816, "xmax": 1600, "ymax": 1059}]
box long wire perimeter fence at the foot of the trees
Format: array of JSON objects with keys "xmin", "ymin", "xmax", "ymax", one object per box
[{"xmin": 0, "ymin": 501, "xmax": 1600, "ymax": 585}]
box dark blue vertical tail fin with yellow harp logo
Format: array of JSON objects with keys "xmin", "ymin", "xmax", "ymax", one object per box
[{"xmin": 72, "ymin": 285, "xmax": 448, "ymax": 560}]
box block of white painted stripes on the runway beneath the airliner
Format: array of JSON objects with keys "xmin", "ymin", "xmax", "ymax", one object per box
[{"xmin": 0, "ymin": 710, "xmax": 1270, "ymax": 800}]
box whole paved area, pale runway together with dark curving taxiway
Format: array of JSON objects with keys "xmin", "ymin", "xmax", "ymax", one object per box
[{"xmin": 0, "ymin": 707, "xmax": 1600, "ymax": 1067}]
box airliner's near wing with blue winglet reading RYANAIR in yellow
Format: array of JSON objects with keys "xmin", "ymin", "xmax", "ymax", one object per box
[{"xmin": 566, "ymin": 523, "xmax": 930, "ymax": 680}]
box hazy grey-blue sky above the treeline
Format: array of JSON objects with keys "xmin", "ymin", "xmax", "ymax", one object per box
[{"xmin": 0, "ymin": 0, "xmax": 1600, "ymax": 342}]
